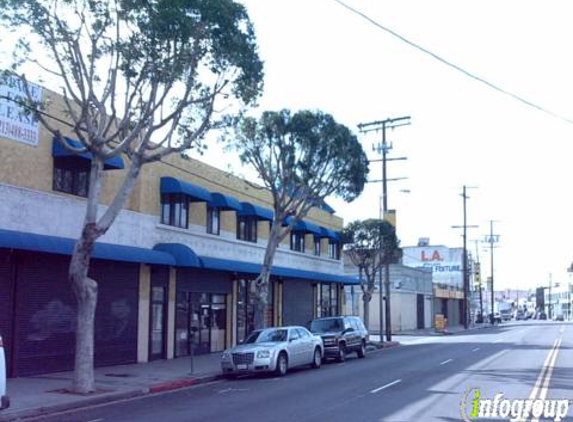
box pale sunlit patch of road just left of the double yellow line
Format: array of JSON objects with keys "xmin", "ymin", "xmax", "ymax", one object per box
[{"xmin": 364, "ymin": 327, "xmax": 558, "ymax": 422}]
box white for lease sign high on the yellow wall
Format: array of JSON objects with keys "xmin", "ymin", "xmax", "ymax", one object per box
[{"xmin": 0, "ymin": 77, "xmax": 42, "ymax": 146}]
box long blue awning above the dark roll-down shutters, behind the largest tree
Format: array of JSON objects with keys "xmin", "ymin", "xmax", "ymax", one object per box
[{"xmin": 0, "ymin": 229, "xmax": 175, "ymax": 265}]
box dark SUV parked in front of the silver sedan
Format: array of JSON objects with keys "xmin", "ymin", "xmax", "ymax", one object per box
[{"xmin": 310, "ymin": 316, "xmax": 368, "ymax": 362}]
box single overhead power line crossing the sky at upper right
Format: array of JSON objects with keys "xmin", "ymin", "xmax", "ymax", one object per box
[{"xmin": 333, "ymin": 0, "xmax": 573, "ymax": 125}]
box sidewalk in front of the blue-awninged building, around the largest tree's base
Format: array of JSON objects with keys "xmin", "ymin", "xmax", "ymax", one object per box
[{"xmin": 0, "ymin": 341, "xmax": 400, "ymax": 422}]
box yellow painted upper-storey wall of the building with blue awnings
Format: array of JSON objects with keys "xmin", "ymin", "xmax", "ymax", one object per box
[{"xmin": 0, "ymin": 83, "xmax": 342, "ymax": 231}]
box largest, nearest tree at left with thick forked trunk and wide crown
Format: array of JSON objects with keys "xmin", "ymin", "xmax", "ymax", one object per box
[{"xmin": 0, "ymin": 0, "xmax": 263, "ymax": 393}]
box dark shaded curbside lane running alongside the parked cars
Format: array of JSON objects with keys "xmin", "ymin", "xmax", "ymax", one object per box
[{"xmin": 26, "ymin": 330, "xmax": 528, "ymax": 422}]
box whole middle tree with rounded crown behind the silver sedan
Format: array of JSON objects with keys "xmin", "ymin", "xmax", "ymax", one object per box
[{"xmin": 233, "ymin": 110, "xmax": 368, "ymax": 328}]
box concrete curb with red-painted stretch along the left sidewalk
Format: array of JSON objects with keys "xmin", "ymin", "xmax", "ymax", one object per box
[{"xmin": 0, "ymin": 374, "xmax": 222, "ymax": 422}]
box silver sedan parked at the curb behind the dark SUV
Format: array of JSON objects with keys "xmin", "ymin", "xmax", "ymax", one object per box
[{"xmin": 221, "ymin": 326, "xmax": 324, "ymax": 378}]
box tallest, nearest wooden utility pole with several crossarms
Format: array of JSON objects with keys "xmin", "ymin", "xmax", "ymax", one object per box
[{"xmin": 358, "ymin": 116, "xmax": 410, "ymax": 341}]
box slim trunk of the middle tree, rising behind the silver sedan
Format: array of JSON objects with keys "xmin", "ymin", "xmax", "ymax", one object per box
[{"xmin": 255, "ymin": 221, "xmax": 280, "ymax": 329}]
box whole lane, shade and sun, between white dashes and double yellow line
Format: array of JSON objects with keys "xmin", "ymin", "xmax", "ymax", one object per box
[{"xmin": 286, "ymin": 322, "xmax": 552, "ymax": 421}]
